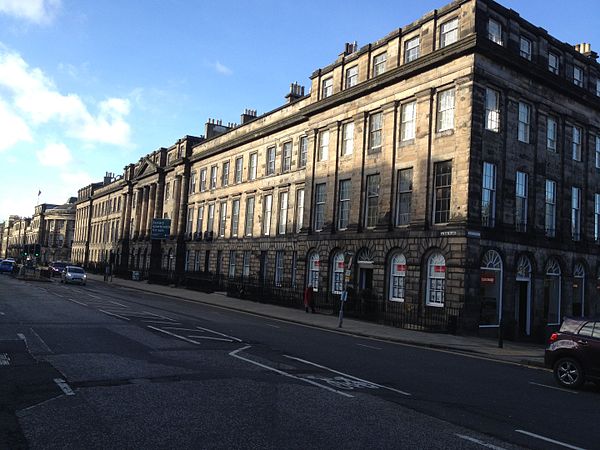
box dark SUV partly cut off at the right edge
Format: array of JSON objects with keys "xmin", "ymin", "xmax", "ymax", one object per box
[{"xmin": 544, "ymin": 317, "xmax": 600, "ymax": 389}]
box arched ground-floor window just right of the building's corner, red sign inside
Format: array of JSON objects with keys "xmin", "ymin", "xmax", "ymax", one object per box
[{"xmin": 479, "ymin": 250, "xmax": 502, "ymax": 326}]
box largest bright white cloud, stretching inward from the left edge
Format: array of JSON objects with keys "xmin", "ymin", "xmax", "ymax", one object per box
[{"xmin": 0, "ymin": 45, "xmax": 130, "ymax": 146}]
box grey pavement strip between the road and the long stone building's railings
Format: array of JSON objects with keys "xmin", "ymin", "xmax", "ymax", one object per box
[{"xmin": 88, "ymin": 274, "xmax": 545, "ymax": 367}]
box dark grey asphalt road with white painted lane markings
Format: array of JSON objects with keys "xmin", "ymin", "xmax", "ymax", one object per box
[{"xmin": 0, "ymin": 276, "xmax": 600, "ymax": 449}]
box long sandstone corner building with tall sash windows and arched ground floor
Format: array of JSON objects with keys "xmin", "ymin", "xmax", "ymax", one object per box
[{"xmin": 74, "ymin": 0, "xmax": 600, "ymax": 339}]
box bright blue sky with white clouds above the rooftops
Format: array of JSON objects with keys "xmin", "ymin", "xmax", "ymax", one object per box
[{"xmin": 0, "ymin": 0, "xmax": 600, "ymax": 221}]
